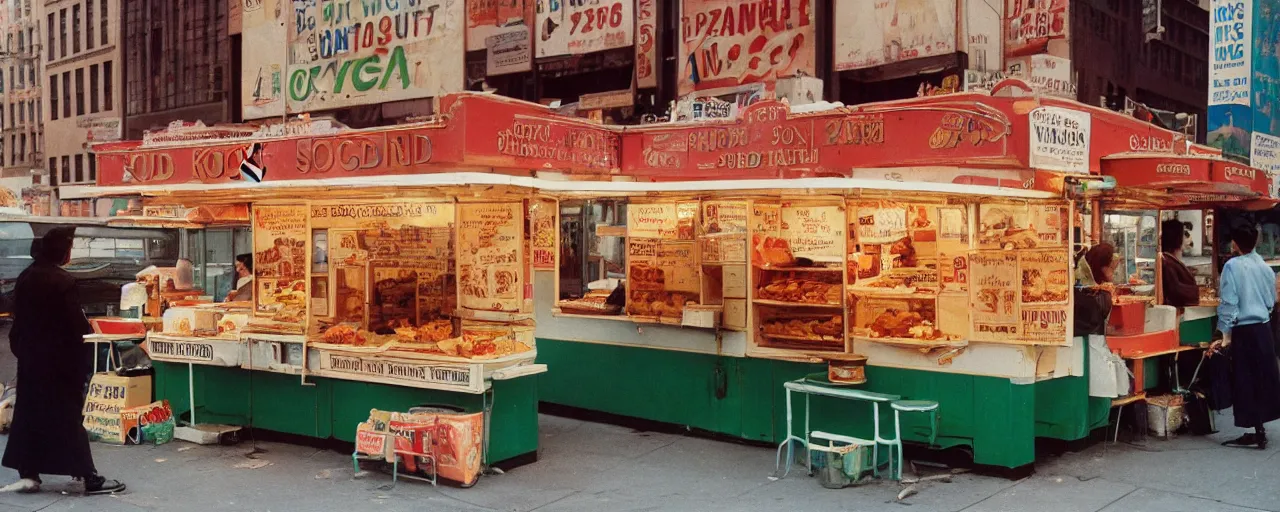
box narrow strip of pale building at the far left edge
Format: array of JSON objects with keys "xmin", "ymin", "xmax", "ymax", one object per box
[{"xmin": 0, "ymin": 0, "xmax": 49, "ymax": 212}]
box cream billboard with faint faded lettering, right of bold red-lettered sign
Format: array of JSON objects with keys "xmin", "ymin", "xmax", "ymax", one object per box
[{"xmin": 832, "ymin": 0, "xmax": 956, "ymax": 72}]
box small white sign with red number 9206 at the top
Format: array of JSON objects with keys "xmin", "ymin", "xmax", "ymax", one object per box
[{"xmin": 535, "ymin": 0, "xmax": 635, "ymax": 58}]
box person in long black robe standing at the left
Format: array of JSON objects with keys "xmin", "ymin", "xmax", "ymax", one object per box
[{"xmin": 0, "ymin": 228, "xmax": 124, "ymax": 494}]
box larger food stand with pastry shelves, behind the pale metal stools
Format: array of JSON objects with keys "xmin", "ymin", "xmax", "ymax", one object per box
[{"xmin": 535, "ymin": 88, "xmax": 1106, "ymax": 467}]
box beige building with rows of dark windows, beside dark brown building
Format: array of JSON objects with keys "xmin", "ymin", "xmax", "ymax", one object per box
[{"xmin": 42, "ymin": 0, "xmax": 122, "ymax": 216}]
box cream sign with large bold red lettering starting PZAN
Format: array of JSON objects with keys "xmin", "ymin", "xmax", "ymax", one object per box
[{"xmin": 677, "ymin": 0, "xmax": 817, "ymax": 95}]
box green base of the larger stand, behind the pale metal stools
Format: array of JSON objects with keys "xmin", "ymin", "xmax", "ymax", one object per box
[{"xmin": 538, "ymin": 338, "xmax": 1111, "ymax": 470}]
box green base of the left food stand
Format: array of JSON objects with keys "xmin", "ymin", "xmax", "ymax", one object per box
[{"xmin": 154, "ymin": 361, "xmax": 538, "ymax": 467}]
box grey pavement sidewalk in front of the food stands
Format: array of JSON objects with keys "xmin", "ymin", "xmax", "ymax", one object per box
[{"xmin": 0, "ymin": 416, "xmax": 1280, "ymax": 512}]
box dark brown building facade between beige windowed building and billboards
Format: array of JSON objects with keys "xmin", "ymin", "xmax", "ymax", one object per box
[{"xmin": 120, "ymin": 0, "xmax": 235, "ymax": 138}]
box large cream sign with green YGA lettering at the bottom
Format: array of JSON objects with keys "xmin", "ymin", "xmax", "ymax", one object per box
[{"xmin": 287, "ymin": 0, "xmax": 466, "ymax": 113}]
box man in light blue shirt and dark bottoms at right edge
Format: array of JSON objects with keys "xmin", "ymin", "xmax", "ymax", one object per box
[{"xmin": 1210, "ymin": 224, "xmax": 1280, "ymax": 449}]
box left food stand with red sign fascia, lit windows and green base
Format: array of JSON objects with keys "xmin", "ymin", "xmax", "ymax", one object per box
[{"xmin": 68, "ymin": 95, "xmax": 634, "ymax": 465}]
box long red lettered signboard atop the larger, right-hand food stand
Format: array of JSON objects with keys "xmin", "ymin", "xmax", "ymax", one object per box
[{"xmin": 623, "ymin": 101, "xmax": 1011, "ymax": 179}]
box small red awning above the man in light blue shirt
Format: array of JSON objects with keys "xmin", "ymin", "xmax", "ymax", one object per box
[{"xmin": 1102, "ymin": 154, "xmax": 1272, "ymax": 207}]
